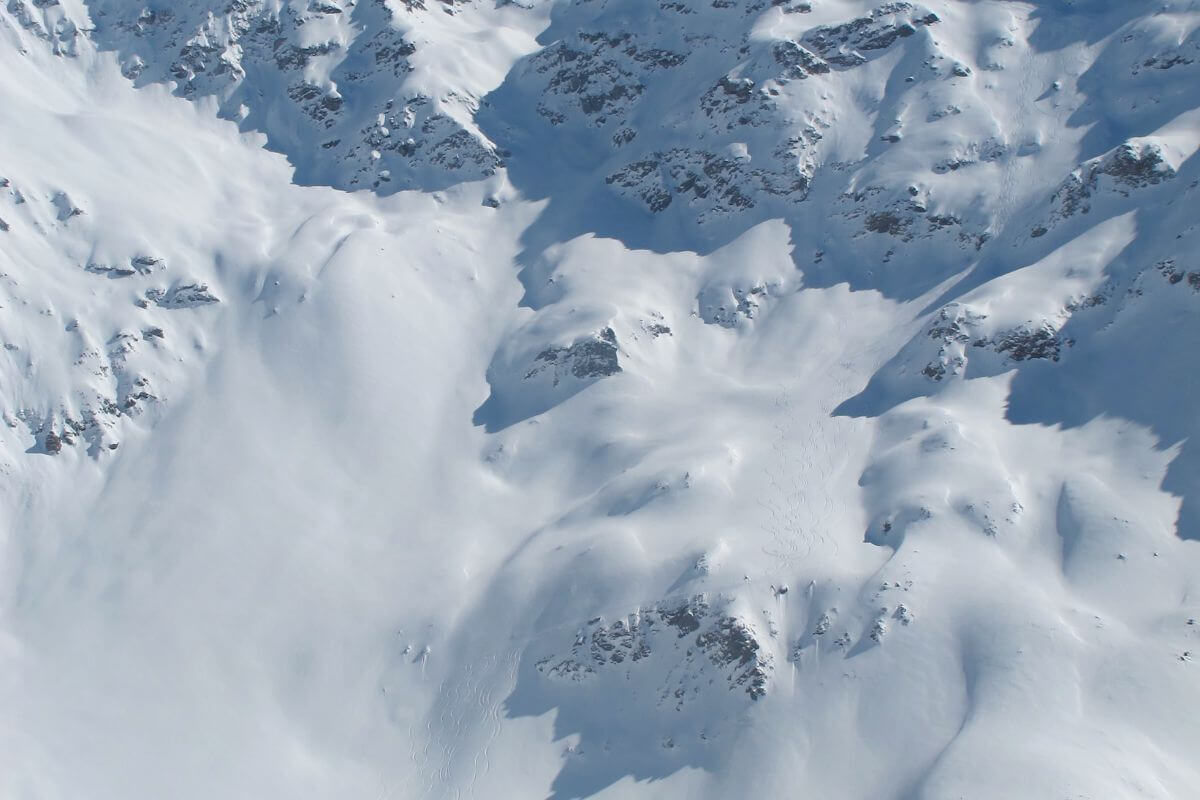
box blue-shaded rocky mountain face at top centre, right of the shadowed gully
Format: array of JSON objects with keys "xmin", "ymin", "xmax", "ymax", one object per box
[{"xmin": 496, "ymin": 0, "xmax": 955, "ymax": 225}]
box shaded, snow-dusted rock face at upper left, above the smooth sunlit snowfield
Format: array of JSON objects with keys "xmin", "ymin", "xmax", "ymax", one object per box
[{"xmin": 91, "ymin": 0, "xmax": 504, "ymax": 193}]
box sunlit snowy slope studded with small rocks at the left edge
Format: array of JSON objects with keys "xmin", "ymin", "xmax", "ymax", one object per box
[{"xmin": 0, "ymin": 122, "xmax": 226, "ymax": 458}]
